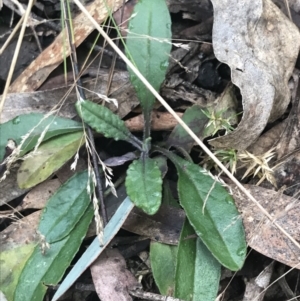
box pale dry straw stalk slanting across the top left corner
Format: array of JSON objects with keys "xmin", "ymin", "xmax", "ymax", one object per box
[{"xmin": 0, "ymin": 0, "xmax": 35, "ymax": 121}]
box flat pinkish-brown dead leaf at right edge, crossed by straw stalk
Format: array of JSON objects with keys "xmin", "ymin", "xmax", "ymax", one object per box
[{"xmin": 231, "ymin": 185, "xmax": 300, "ymax": 269}]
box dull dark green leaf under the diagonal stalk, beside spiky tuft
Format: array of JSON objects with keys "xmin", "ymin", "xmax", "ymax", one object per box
[{"xmin": 166, "ymin": 105, "xmax": 209, "ymax": 152}]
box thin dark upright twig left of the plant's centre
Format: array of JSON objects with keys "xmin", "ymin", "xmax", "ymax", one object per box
[{"xmin": 63, "ymin": 1, "xmax": 108, "ymax": 227}]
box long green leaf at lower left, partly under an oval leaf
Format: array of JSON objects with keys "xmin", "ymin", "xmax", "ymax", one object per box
[{"xmin": 13, "ymin": 205, "xmax": 93, "ymax": 301}]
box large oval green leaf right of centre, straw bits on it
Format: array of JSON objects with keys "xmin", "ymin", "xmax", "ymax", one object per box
[{"xmin": 170, "ymin": 155, "xmax": 247, "ymax": 271}]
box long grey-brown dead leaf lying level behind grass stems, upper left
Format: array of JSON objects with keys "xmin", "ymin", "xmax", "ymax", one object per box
[{"xmin": 1, "ymin": 69, "xmax": 139, "ymax": 122}]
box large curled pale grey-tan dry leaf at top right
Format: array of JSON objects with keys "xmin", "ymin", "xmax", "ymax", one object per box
[{"xmin": 210, "ymin": 0, "xmax": 300, "ymax": 150}]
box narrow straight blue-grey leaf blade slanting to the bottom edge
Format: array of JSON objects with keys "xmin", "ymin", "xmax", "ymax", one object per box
[{"xmin": 52, "ymin": 197, "xmax": 134, "ymax": 301}]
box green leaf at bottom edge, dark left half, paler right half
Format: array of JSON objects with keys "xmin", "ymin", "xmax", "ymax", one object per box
[{"xmin": 175, "ymin": 220, "xmax": 221, "ymax": 301}]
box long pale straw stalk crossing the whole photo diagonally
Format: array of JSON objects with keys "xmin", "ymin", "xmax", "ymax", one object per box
[{"xmin": 74, "ymin": 0, "xmax": 300, "ymax": 250}]
